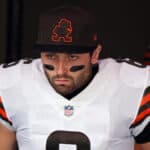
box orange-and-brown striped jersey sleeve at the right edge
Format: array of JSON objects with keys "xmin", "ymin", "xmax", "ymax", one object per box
[{"xmin": 130, "ymin": 86, "xmax": 150, "ymax": 144}]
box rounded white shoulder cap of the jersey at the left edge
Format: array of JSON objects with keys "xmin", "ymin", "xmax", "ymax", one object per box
[{"xmin": 0, "ymin": 61, "xmax": 22, "ymax": 89}]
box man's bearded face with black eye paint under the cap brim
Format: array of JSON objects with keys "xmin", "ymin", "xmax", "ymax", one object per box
[{"xmin": 41, "ymin": 46, "xmax": 101, "ymax": 96}]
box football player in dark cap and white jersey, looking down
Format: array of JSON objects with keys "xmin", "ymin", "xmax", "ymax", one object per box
[{"xmin": 0, "ymin": 4, "xmax": 150, "ymax": 150}]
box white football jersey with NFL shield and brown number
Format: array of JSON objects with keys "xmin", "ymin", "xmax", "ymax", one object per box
[{"xmin": 0, "ymin": 59, "xmax": 150, "ymax": 150}]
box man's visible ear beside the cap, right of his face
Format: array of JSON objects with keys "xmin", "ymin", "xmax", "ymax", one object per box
[{"xmin": 91, "ymin": 44, "xmax": 102, "ymax": 64}]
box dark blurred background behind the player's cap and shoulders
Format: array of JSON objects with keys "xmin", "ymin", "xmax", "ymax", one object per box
[{"xmin": 0, "ymin": 0, "xmax": 150, "ymax": 63}]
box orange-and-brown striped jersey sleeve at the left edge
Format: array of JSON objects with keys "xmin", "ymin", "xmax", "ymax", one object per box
[{"xmin": 0, "ymin": 96, "xmax": 13, "ymax": 129}]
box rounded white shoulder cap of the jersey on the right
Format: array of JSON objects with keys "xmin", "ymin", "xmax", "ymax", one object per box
[{"xmin": 119, "ymin": 60, "xmax": 148, "ymax": 88}]
